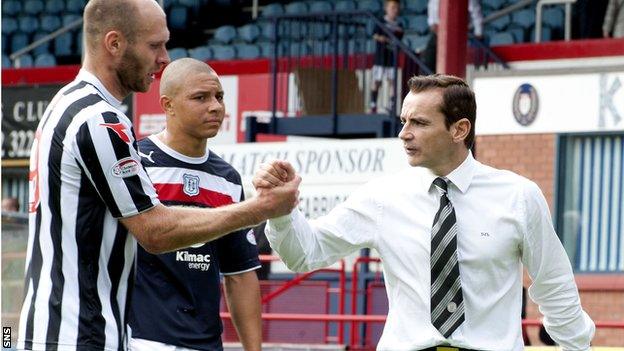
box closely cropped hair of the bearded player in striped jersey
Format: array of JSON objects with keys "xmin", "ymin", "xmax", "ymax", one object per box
[{"xmin": 83, "ymin": 0, "xmax": 138, "ymax": 50}]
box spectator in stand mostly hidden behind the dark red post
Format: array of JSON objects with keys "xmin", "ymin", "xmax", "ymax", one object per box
[{"xmin": 422, "ymin": 0, "xmax": 483, "ymax": 73}]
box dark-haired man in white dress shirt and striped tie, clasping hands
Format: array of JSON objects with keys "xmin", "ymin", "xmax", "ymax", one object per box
[{"xmin": 254, "ymin": 75, "xmax": 595, "ymax": 351}]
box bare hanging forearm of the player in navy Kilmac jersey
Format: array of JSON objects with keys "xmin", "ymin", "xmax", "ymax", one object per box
[{"xmin": 224, "ymin": 271, "xmax": 262, "ymax": 351}]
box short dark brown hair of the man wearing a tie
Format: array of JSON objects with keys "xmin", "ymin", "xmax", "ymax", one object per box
[{"xmin": 407, "ymin": 74, "xmax": 477, "ymax": 149}]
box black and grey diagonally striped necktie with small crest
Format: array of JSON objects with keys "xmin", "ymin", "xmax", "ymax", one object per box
[{"xmin": 430, "ymin": 177, "xmax": 464, "ymax": 338}]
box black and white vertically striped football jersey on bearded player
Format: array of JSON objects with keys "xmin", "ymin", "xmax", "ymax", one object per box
[{"xmin": 18, "ymin": 69, "xmax": 159, "ymax": 350}]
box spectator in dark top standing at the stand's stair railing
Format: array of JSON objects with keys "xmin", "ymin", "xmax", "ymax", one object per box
[{"xmin": 370, "ymin": 0, "xmax": 403, "ymax": 113}]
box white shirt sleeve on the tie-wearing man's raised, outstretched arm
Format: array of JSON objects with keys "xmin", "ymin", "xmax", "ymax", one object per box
[{"xmin": 266, "ymin": 186, "xmax": 381, "ymax": 272}]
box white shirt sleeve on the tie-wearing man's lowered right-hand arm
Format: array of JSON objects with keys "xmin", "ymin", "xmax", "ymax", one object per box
[{"xmin": 522, "ymin": 182, "xmax": 595, "ymax": 350}]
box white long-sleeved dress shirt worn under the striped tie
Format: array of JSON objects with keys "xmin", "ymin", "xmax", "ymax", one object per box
[{"xmin": 267, "ymin": 154, "xmax": 595, "ymax": 351}]
